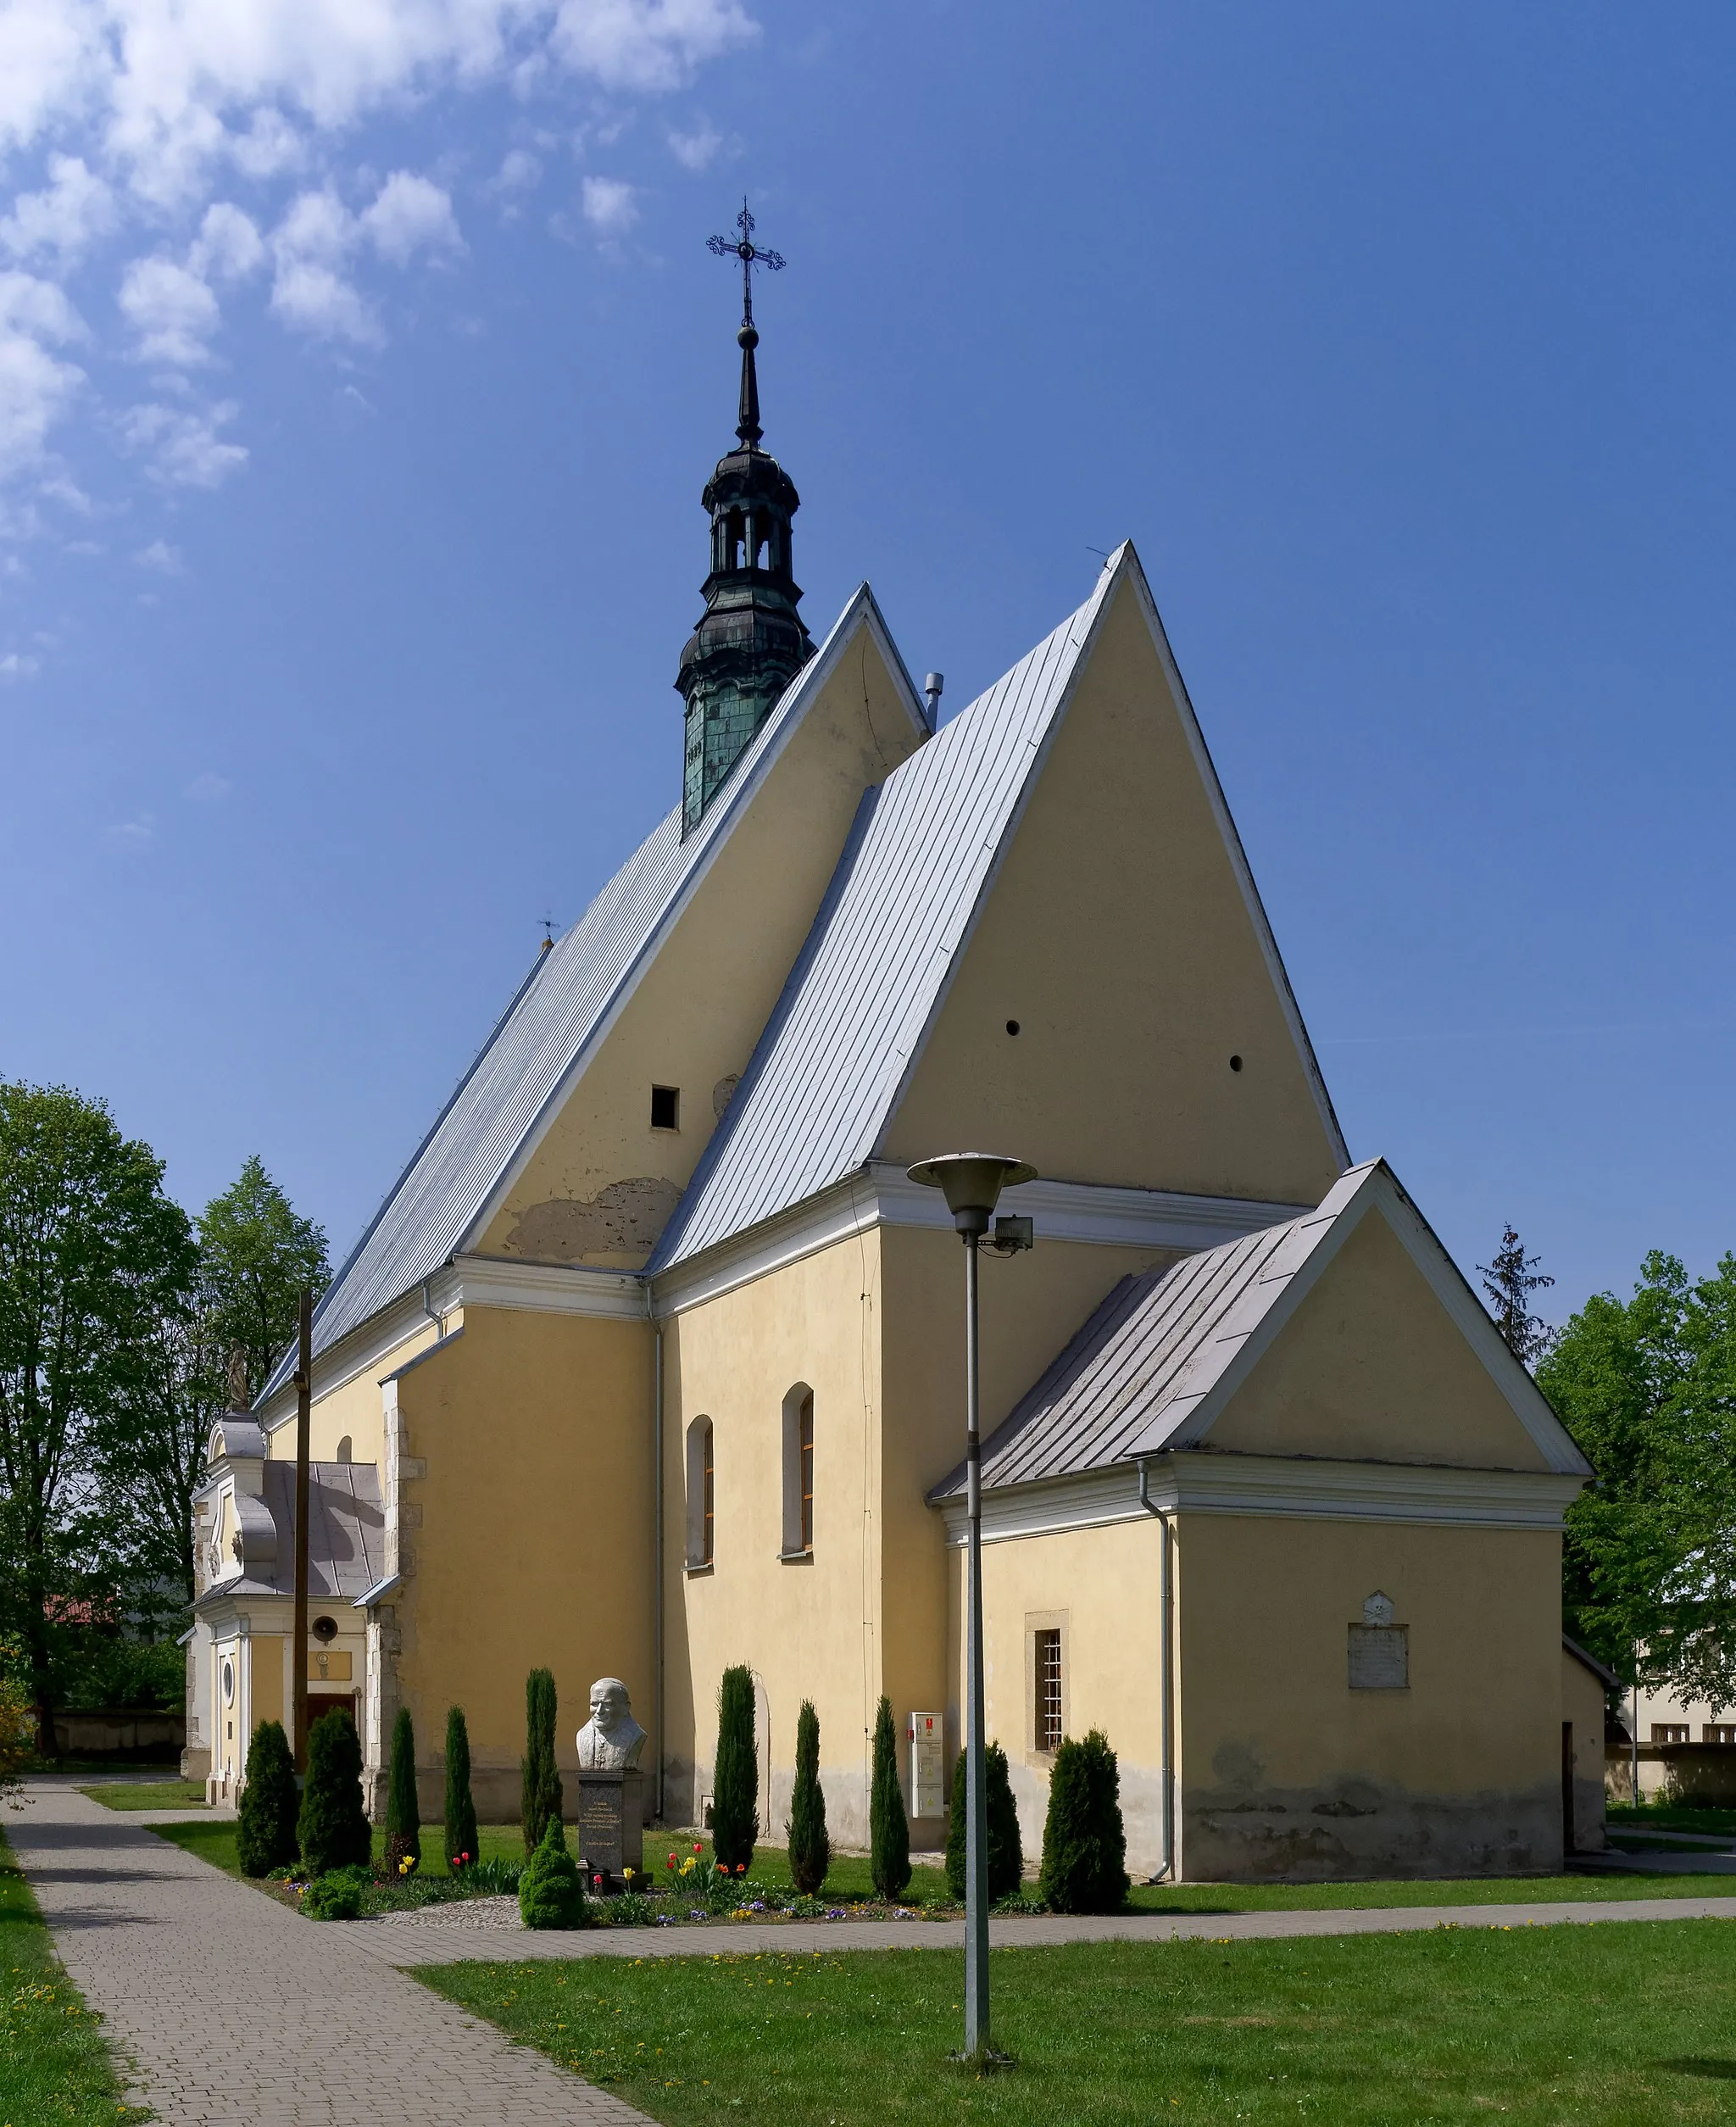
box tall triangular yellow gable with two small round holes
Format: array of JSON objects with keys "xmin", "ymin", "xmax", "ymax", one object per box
[{"xmin": 887, "ymin": 587, "xmax": 1338, "ymax": 1204}]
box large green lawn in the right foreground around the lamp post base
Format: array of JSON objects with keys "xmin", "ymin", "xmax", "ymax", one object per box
[{"xmin": 415, "ymin": 1921, "xmax": 1736, "ymax": 2127}]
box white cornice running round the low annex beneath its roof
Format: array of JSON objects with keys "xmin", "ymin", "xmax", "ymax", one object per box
[{"xmin": 940, "ymin": 1455, "xmax": 1583, "ymax": 1545}]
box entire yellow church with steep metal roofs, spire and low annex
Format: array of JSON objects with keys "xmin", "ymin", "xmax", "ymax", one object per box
[{"xmin": 187, "ymin": 221, "xmax": 1604, "ymax": 1880}]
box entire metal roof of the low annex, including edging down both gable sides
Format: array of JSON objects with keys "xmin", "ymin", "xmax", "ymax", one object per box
[{"xmin": 930, "ymin": 1159, "xmax": 1589, "ymax": 1501}]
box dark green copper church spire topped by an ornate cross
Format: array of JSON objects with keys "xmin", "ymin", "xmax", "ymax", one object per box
[{"xmin": 675, "ymin": 200, "xmax": 813, "ymax": 834}]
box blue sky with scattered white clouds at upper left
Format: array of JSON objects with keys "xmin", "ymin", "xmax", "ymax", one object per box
[{"xmin": 0, "ymin": 0, "xmax": 1736, "ymax": 1317}]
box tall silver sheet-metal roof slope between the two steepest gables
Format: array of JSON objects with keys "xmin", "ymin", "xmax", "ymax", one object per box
[{"xmin": 648, "ymin": 564, "xmax": 1121, "ymax": 1272}]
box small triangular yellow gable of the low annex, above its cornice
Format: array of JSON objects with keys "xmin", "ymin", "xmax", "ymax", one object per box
[{"xmin": 1209, "ymin": 1206, "xmax": 1549, "ymax": 1470}]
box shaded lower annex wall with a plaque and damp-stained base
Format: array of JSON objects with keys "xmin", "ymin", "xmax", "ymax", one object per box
[{"xmin": 1177, "ymin": 1514, "xmax": 1561, "ymax": 1878}]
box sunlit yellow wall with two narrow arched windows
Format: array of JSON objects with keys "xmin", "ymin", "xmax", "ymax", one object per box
[{"xmin": 664, "ymin": 1232, "xmax": 883, "ymax": 1844}]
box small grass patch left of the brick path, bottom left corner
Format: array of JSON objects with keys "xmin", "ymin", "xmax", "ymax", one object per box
[{"xmin": 0, "ymin": 1834, "xmax": 151, "ymax": 2127}]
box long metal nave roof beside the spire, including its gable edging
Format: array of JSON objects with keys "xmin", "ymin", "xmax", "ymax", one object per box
[{"xmin": 262, "ymin": 585, "xmax": 921, "ymax": 1400}]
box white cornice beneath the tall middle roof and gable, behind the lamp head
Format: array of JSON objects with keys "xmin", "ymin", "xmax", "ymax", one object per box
[{"xmin": 651, "ymin": 1161, "xmax": 1313, "ymax": 1315}]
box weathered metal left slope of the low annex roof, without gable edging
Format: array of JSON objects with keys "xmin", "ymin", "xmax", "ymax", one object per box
[{"xmin": 930, "ymin": 1161, "xmax": 1377, "ymax": 1500}]
